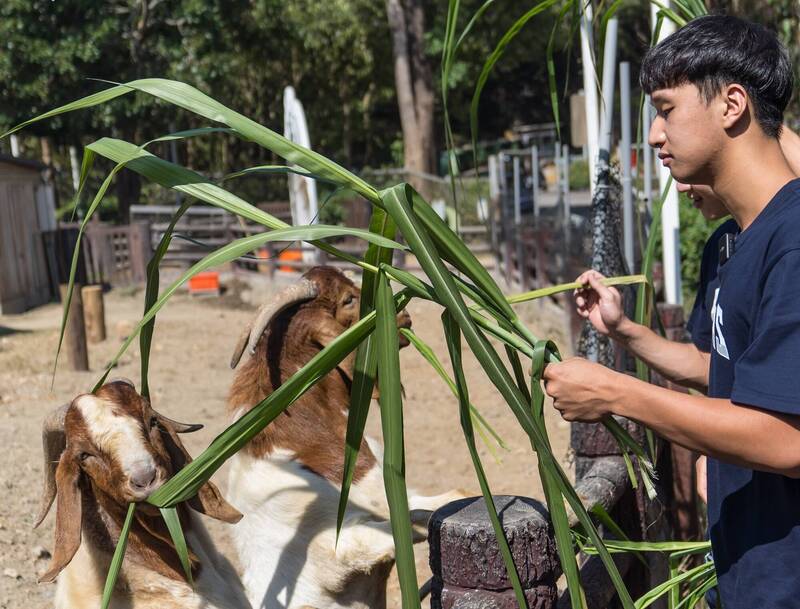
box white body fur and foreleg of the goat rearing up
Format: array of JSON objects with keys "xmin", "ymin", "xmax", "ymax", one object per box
[{"xmin": 227, "ymin": 428, "xmax": 463, "ymax": 609}]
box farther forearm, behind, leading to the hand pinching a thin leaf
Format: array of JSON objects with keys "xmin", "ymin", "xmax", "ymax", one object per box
[{"xmin": 612, "ymin": 319, "xmax": 709, "ymax": 391}]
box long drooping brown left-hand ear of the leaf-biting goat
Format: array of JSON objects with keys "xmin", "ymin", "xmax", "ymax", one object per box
[{"xmin": 39, "ymin": 452, "xmax": 81, "ymax": 582}]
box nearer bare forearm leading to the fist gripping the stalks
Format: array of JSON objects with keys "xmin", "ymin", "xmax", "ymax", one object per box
[{"xmin": 612, "ymin": 375, "xmax": 800, "ymax": 477}]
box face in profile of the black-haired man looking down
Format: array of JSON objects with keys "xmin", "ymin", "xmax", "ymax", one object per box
[{"xmin": 648, "ymin": 84, "xmax": 725, "ymax": 184}]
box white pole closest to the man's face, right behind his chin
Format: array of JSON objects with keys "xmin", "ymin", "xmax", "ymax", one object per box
[{"xmin": 650, "ymin": 1, "xmax": 683, "ymax": 304}]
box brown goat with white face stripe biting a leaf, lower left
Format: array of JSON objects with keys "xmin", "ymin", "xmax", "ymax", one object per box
[{"xmin": 36, "ymin": 380, "xmax": 250, "ymax": 609}]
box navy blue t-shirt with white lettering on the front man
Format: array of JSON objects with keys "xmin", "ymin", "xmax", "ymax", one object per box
[{"xmin": 708, "ymin": 179, "xmax": 800, "ymax": 609}]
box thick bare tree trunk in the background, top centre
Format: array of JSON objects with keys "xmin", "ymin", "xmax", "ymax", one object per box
[{"xmin": 386, "ymin": 0, "xmax": 434, "ymax": 197}]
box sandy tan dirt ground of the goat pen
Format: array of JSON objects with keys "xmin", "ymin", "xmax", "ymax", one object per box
[{"xmin": 0, "ymin": 270, "xmax": 569, "ymax": 609}]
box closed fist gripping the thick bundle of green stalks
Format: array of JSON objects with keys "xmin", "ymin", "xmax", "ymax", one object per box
[{"xmin": 543, "ymin": 357, "xmax": 627, "ymax": 423}]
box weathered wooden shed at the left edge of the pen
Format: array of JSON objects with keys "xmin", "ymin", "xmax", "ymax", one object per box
[{"xmin": 0, "ymin": 155, "xmax": 56, "ymax": 314}]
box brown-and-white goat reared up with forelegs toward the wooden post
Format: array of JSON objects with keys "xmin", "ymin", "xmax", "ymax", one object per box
[{"xmin": 228, "ymin": 267, "xmax": 464, "ymax": 609}]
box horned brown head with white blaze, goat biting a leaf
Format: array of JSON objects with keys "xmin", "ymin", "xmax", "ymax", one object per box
[{"xmin": 34, "ymin": 380, "xmax": 241, "ymax": 581}]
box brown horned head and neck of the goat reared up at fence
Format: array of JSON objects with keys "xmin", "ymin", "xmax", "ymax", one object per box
[{"xmin": 228, "ymin": 267, "xmax": 411, "ymax": 484}]
